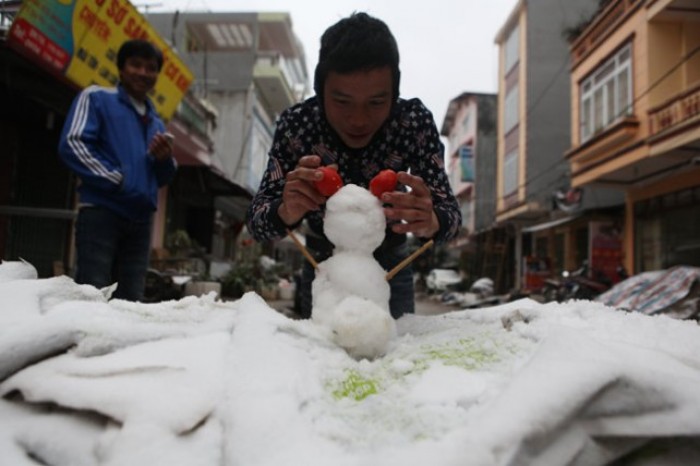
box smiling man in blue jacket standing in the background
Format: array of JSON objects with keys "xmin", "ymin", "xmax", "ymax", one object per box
[{"xmin": 58, "ymin": 40, "xmax": 177, "ymax": 301}]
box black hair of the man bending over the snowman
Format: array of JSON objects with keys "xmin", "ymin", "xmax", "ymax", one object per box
[{"xmin": 314, "ymin": 13, "xmax": 401, "ymax": 107}]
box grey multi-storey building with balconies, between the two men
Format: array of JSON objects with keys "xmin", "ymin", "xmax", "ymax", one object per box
[{"xmin": 148, "ymin": 12, "xmax": 309, "ymax": 259}]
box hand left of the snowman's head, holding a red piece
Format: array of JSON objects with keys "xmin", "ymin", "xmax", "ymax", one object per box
[{"xmin": 277, "ymin": 155, "xmax": 326, "ymax": 225}]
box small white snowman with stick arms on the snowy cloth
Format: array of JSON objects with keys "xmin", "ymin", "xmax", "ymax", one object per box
[{"xmin": 311, "ymin": 184, "xmax": 396, "ymax": 360}]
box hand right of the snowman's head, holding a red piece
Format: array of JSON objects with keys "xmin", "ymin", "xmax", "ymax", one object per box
[{"xmin": 381, "ymin": 172, "xmax": 440, "ymax": 238}]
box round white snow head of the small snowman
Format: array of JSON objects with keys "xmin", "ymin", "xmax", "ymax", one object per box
[{"xmin": 323, "ymin": 184, "xmax": 386, "ymax": 254}]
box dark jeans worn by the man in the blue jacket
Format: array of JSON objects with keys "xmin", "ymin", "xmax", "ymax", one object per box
[{"xmin": 75, "ymin": 207, "xmax": 151, "ymax": 301}]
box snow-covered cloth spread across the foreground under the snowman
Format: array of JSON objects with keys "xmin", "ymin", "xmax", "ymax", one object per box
[{"xmin": 0, "ymin": 265, "xmax": 700, "ymax": 466}]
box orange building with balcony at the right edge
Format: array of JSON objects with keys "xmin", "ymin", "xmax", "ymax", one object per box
[{"xmin": 566, "ymin": 0, "xmax": 700, "ymax": 273}]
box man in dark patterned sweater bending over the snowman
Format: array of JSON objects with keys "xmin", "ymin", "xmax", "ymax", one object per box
[{"xmin": 247, "ymin": 12, "xmax": 462, "ymax": 318}]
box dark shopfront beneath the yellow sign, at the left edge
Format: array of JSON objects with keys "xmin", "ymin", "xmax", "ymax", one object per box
[{"xmin": 0, "ymin": 41, "xmax": 76, "ymax": 276}]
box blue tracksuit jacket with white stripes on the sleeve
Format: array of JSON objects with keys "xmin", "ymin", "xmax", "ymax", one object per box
[{"xmin": 58, "ymin": 85, "xmax": 177, "ymax": 221}]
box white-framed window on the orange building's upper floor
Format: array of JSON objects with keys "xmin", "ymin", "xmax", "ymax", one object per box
[{"xmin": 579, "ymin": 44, "xmax": 632, "ymax": 143}]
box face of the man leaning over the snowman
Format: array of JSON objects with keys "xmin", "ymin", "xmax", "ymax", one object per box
[{"xmin": 323, "ymin": 66, "xmax": 394, "ymax": 149}]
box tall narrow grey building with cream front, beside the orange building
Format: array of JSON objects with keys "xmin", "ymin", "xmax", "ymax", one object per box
[{"xmin": 494, "ymin": 0, "xmax": 623, "ymax": 289}]
